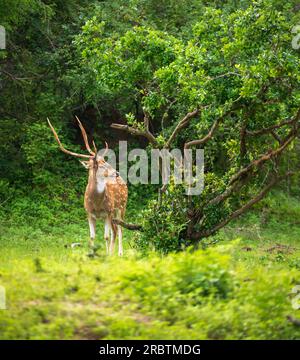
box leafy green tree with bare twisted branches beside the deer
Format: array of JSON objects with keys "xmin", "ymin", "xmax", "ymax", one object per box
[{"xmin": 76, "ymin": 1, "xmax": 300, "ymax": 251}]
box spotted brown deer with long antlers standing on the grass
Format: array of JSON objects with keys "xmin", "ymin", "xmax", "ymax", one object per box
[{"xmin": 47, "ymin": 117, "xmax": 128, "ymax": 256}]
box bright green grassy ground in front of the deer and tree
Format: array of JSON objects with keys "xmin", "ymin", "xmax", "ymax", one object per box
[{"xmin": 0, "ymin": 195, "xmax": 300, "ymax": 339}]
